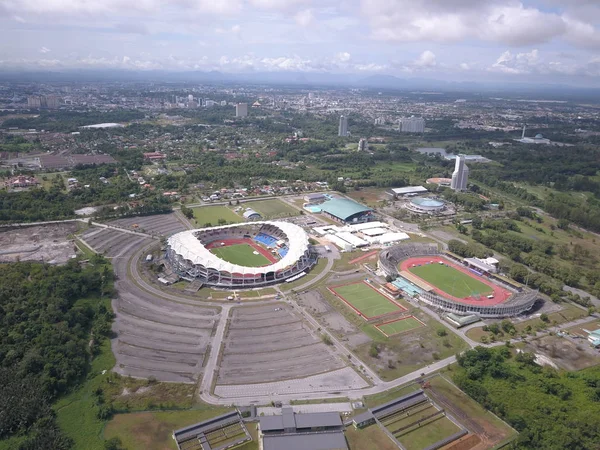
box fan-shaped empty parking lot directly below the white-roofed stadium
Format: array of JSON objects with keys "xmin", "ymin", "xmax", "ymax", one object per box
[{"xmin": 217, "ymin": 303, "xmax": 344, "ymax": 385}]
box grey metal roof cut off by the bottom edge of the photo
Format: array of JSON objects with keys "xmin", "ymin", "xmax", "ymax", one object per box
[{"xmin": 263, "ymin": 431, "xmax": 348, "ymax": 450}]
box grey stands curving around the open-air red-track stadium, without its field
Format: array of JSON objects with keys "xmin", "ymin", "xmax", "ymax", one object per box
[{"xmin": 378, "ymin": 243, "xmax": 538, "ymax": 318}]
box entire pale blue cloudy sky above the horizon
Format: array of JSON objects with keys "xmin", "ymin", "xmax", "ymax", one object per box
[{"xmin": 0, "ymin": 0, "xmax": 600, "ymax": 85}]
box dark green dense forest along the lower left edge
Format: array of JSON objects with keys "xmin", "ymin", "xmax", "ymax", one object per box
[{"xmin": 0, "ymin": 256, "xmax": 113, "ymax": 450}]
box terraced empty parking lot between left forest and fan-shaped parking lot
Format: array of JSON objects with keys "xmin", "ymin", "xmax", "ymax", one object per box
[{"xmin": 113, "ymin": 292, "xmax": 217, "ymax": 383}]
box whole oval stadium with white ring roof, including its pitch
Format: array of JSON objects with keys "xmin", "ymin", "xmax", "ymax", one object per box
[{"xmin": 166, "ymin": 221, "xmax": 317, "ymax": 289}]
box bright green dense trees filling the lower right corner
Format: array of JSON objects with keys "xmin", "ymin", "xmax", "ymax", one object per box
[{"xmin": 453, "ymin": 347, "xmax": 600, "ymax": 450}]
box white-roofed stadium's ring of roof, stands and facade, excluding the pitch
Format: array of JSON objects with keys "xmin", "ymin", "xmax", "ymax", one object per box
[{"xmin": 166, "ymin": 221, "xmax": 317, "ymax": 289}]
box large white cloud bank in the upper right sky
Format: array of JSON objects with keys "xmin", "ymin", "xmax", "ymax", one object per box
[{"xmin": 361, "ymin": 0, "xmax": 600, "ymax": 46}]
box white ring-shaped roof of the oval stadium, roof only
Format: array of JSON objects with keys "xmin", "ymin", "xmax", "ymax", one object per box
[{"xmin": 167, "ymin": 221, "xmax": 309, "ymax": 275}]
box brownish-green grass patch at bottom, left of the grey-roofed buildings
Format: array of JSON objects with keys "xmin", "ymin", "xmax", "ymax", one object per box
[{"xmin": 104, "ymin": 405, "xmax": 230, "ymax": 450}]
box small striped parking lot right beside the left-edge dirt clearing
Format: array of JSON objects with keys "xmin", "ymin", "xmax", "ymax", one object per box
[{"xmin": 80, "ymin": 227, "xmax": 151, "ymax": 257}]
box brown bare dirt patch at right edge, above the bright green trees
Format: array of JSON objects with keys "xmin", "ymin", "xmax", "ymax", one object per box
[{"xmin": 526, "ymin": 336, "xmax": 600, "ymax": 371}]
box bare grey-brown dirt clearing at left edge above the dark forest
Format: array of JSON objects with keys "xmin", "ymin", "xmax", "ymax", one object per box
[{"xmin": 0, "ymin": 223, "xmax": 79, "ymax": 264}]
